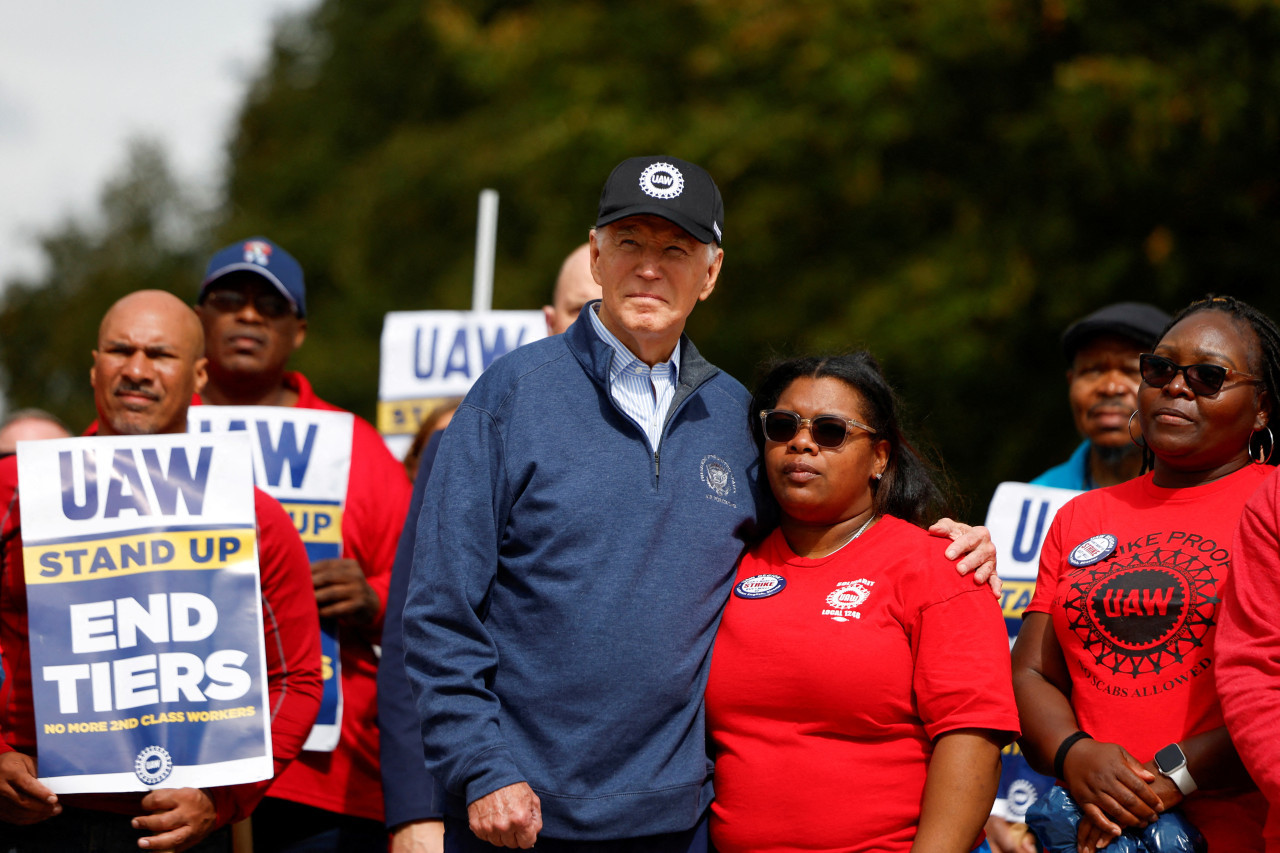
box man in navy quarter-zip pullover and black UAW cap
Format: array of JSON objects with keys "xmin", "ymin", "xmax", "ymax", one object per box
[{"xmin": 404, "ymin": 156, "xmax": 986, "ymax": 853}]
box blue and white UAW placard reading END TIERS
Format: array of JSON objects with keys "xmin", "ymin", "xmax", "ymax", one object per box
[{"xmin": 18, "ymin": 435, "xmax": 273, "ymax": 794}]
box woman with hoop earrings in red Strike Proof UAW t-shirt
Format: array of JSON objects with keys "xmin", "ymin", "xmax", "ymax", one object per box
[{"xmin": 1014, "ymin": 297, "xmax": 1280, "ymax": 853}]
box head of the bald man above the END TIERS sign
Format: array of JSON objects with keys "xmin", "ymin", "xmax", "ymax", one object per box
[{"xmin": 90, "ymin": 291, "xmax": 206, "ymax": 435}]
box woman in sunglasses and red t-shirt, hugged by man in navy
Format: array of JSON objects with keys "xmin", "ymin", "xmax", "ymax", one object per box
[{"xmin": 707, "ymin": 352, "xmax": 1018, "ymax": 853}]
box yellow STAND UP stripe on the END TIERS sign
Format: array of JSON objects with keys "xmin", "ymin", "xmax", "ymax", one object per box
[{"xmin": 22, "ymin": 528, "xmax": 257, "ymax": 584}]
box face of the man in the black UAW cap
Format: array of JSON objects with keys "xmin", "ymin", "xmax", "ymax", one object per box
[{"xmin": 590, "ymin": 215, "xmax": 724, "ymax": 365}]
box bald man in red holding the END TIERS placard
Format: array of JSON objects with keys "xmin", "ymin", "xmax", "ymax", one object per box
[{"xmin": 0, "ymin": 291, "xmax": 321, "ymax": 853}]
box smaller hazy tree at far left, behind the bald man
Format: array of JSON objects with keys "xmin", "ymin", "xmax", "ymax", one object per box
[{"xmin": 0, "ymin": 141, "xmax": 207, "ymax": 432}]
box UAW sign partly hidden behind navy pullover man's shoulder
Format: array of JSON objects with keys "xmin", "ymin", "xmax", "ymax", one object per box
[{"xmin": 378, "ymin": 311, "xmax": 547, "ymax": 459}]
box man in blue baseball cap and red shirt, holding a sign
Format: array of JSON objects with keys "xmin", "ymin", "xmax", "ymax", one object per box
[{"xmin": 196, "ymin": 237, "xmax": 410, "ymax": 853}]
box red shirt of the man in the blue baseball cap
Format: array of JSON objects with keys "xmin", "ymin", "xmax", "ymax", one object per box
[{"xmin": 202, "ymin": 373, "xmax": 412, "ymax": 821}]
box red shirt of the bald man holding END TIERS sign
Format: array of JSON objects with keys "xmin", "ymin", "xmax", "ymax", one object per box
[{"xmin": 0, "ymin": 456, "xmax": 321, "ymax": 825}]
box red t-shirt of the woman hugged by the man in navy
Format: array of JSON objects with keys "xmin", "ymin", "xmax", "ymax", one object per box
[{"xmin": 707, "ymin": 517, "xmax": 1018, "ymax": 853}]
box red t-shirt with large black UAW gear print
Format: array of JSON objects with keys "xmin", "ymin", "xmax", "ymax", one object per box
[{"xmin": 1027, "ymin": 465, "xmax": 1271, "ymax": 850}]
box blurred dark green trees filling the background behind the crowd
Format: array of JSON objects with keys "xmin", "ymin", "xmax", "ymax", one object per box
[{"xmin": 10, "ymin": 0, "xmax": 1280, "ymax": 507}]
